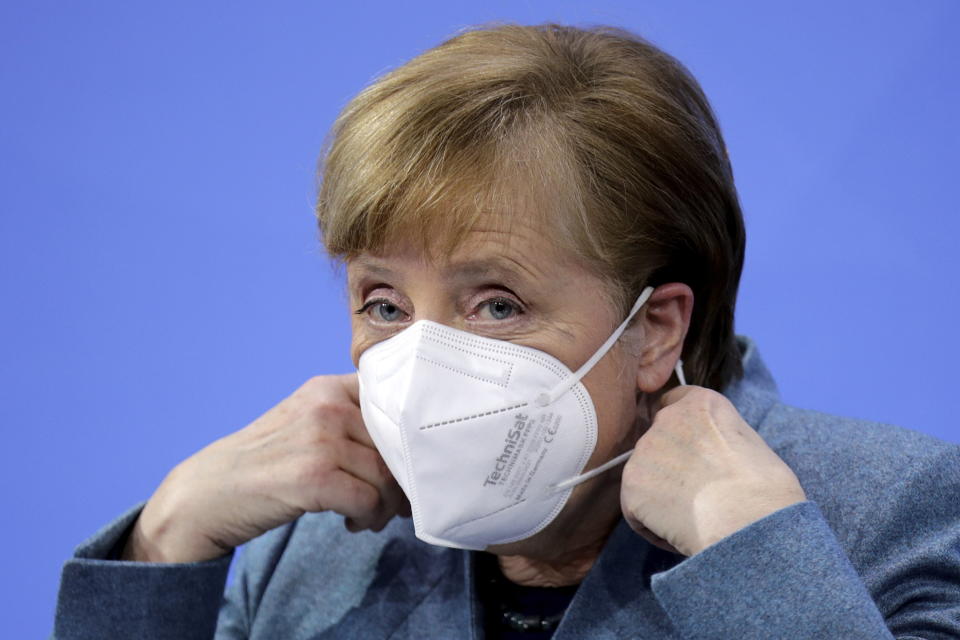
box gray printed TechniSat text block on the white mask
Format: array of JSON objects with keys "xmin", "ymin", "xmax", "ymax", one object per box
[{"xmin": 483, "ymin": 412, "xmax": 561, "ymax": 502}]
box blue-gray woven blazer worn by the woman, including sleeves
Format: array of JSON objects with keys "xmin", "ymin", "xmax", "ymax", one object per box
[{"xmin": 54, "ymin": 340, "xmax": 960, "ymax": 640}]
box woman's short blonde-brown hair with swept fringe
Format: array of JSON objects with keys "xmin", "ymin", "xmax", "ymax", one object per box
[{"xmin": 317, "ymin": 24, "xmax": 745, "ymax": 389}]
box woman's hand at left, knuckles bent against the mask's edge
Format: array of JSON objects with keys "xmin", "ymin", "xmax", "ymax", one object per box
[{"xmin": 123, "ymin": 374, "xmax": 410, "ymax": 562}]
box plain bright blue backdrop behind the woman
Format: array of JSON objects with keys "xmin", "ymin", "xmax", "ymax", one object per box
[{"xmin": 0, "ymin": 0, "xmax": 960, "ymax": 638}]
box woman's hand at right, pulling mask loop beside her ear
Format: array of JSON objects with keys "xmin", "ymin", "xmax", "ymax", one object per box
[{"xmin": 620, "ymin": 386, "xmax": 806, "ymax": 556}]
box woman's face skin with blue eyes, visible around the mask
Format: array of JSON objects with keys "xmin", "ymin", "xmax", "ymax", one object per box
[{"xmin": 347, "ymin": 214, "xmax": 656, "ymax": 555}]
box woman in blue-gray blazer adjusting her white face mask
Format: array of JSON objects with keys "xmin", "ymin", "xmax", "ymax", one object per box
[{"xmin": 55, "ymin": 25, "xmax": 960, "ymax": 638}]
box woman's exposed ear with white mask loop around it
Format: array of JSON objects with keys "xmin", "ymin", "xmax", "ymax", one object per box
[{"xmin": 637, "ymin": 282, "xmax": 693, "ymax": 393}]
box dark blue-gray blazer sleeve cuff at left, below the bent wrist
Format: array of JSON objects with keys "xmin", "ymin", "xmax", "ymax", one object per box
[{"xmin": 53, "ymin": 505, "xmax": 247, "ymax": 640}]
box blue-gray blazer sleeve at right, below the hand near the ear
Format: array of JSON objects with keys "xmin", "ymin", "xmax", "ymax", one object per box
[{"xmin": 652, "ymin": 447, "xmax": 960, "ymax": 640}]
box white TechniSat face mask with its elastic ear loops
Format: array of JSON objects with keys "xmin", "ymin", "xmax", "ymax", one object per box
[{"xmin": 359, "ymin": 287, "xmax": 682, "ymax": 549}]
